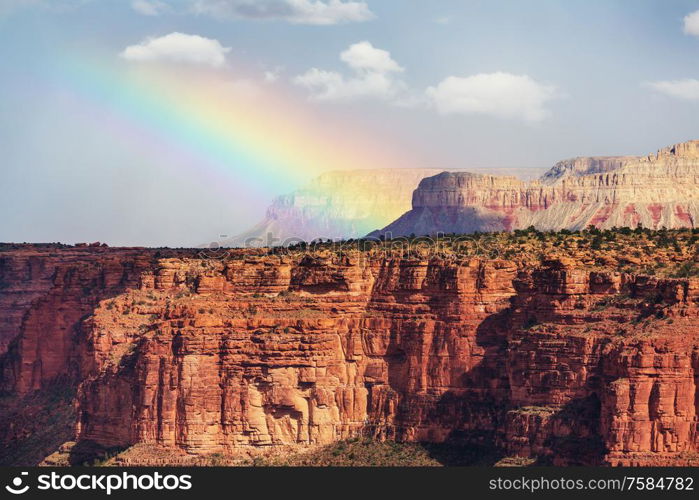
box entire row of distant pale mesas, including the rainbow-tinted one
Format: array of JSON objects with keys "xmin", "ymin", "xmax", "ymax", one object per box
[{"xmin": 227, "ymin": 141, "xmax": 699, "ymax": 247}]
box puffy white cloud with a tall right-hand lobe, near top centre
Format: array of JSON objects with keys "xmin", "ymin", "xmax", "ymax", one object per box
[{"xmin": 292, "ymin": 41, "xmax": 406, "ymax": 101}]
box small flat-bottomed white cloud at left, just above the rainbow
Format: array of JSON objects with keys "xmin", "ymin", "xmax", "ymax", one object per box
[{"xmin": 120, "ymin": 32, "xmax": 231, "ymax": 67}]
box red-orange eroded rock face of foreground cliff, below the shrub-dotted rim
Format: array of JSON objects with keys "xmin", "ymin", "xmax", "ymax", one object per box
[{"xmin": 0, "ymin": 245, "xmax": 699, "ymax": 465}]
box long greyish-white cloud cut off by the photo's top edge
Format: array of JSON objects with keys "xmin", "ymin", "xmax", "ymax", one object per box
[{"xmin": 192, "ymin": 0, "xmax": 374, "ymax": 25}]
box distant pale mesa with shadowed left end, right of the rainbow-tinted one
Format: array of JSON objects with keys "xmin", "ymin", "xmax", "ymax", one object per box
[{"xmin": 373, "ymin": 141, "xmax": 699, "ymax": 236}]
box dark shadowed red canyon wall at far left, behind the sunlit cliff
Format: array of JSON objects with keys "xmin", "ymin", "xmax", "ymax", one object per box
[{"xmin": 0, "ymin": 246, "xmax": 152, "ymax": 393}]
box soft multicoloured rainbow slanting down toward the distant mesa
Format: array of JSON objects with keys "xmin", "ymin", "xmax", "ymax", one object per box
[{"xmin": 45, "ymin": 56, "xmax": 410, "ymax": 202}]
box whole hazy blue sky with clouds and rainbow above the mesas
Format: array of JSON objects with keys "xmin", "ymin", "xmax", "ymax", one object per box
[{"xmin": 0, "ymin": 0, "xmax": 699, "ymax": 246}]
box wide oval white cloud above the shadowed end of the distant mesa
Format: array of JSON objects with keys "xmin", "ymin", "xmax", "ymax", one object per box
[{"xmin": 426, "ymin": 72, "xmax": 557, "ymax": 122}]
